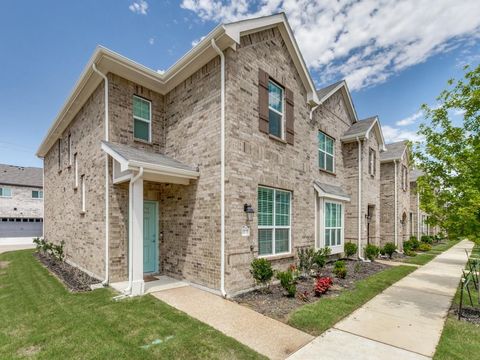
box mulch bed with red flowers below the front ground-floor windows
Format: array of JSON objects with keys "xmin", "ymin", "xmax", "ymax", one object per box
[{"xmin": 233, "ymin": 260, "xmax": 390, "ymax": 323}]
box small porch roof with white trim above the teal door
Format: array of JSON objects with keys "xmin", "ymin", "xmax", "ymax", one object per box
[{"xmin": 102, "ymin": 141, "xmax": 199, "ymax": 179}]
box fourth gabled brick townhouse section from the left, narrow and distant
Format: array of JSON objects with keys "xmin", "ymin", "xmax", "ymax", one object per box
[{"xmin": 380, "ymin": 141, "xmax": 411, "ymax": 250}]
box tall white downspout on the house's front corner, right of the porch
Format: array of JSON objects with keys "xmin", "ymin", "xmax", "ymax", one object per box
[{"xmin": 211, "ymin": 39, "xmax": 227, "ymax": 297}]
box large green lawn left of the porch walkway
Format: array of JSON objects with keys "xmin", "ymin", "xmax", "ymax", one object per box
[{"xmin": 0, "ymin": 250, "xmax": 261, "ymax": 359}]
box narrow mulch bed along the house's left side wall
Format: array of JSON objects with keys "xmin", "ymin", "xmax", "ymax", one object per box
[{"xmin": 34, "ymin": 253, "xmax": 99, "ymax": 292}]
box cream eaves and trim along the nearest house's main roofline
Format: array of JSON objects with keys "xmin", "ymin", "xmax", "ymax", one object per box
[{"xmin": 37, "ymin": 13, "xmax": 319, "ymax": 157}]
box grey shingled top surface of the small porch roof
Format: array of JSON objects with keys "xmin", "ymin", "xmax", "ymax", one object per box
[{"xmin": 102, "ymin": 141, "xmax": 197, "ymax": 171}]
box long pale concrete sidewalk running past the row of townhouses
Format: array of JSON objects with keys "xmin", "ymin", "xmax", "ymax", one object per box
[{"xmin": 289, "ymin": 240, "xmax": 473, "ymax": 360}]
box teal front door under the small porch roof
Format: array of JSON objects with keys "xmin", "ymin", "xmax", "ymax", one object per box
[{"xmin": 143, "ymin": 201, "xmax": 158, "ymax": 273}]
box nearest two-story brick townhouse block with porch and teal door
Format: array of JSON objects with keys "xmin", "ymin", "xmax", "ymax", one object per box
[{"xmin": 37, "ymin": 14, "xmax": 384, "ymax": 295}]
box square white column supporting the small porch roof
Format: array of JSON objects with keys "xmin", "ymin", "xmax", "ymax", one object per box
[{"xmin": 131, "ymin": 176, "xmax": 144, "ymax": 296}]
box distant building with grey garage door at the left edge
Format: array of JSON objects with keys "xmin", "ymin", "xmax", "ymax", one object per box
[{"xmin": 0, "ymin": 164, "xmax": 43, "ymax": 238}]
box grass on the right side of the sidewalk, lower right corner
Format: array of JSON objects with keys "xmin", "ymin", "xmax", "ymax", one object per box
[{"xmin": 433, "ymin": 245, "xmax": 480, "ymax": 360}]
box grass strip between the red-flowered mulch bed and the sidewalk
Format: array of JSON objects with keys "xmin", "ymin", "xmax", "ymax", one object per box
[{"xmin": 288, "ymin": 266, "xmax": 415, "ymax": 335}]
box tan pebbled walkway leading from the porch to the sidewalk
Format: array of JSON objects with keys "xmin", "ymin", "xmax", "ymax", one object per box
[{"xmin": 152, "ymin": 286, "xmax": 313, "ymax": 359}]
